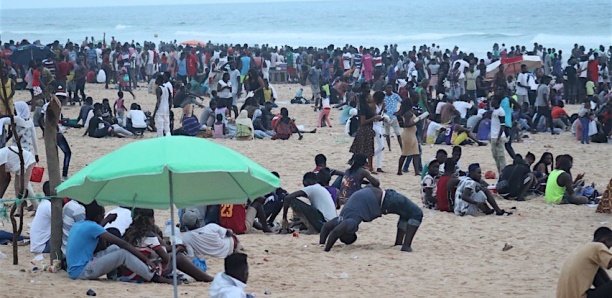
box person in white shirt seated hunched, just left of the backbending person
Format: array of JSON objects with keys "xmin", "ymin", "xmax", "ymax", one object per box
[{"xmin": 282, "ymin": 172, "xmax": 336, "ymax": 233}]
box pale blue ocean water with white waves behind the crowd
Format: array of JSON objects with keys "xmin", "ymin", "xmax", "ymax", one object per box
[{"xmin": 0, "ymin": 0, "xmax": 612, "ymax": 55}]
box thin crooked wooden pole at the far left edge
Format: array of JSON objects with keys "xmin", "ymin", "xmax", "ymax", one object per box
[{"xmin": 0, "ymin": 62, "xmax": 30, "ymax": 265}]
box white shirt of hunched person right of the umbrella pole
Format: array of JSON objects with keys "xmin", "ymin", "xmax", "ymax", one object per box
[{"xmin": 181, "ymin": 223, "xmax": 234, "ymax": 258}]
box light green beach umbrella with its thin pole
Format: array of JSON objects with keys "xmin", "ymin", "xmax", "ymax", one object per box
[{"xmin": 57, "ymin": 136, "xmax": 280, "ymax": 297}]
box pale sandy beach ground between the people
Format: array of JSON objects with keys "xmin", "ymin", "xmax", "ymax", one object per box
[{"xmin": 0, "ymin": 84, "xmax": 612, "ymax": 297}]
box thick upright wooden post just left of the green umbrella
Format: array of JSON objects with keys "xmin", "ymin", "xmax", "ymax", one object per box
[{"xmin": 44, "ymin": 95, "xmax": 63, "ymax": 265}]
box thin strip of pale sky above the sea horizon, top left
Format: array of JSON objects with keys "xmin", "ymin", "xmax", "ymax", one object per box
[{"xmin": 0, "ymin": 0, "xmax": 326, "ymax": 9}]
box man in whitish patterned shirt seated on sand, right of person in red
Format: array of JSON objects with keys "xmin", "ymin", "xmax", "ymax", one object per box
[{"xmin": 455, "ymin": 163, "xmax": 511, "ymax": 216}]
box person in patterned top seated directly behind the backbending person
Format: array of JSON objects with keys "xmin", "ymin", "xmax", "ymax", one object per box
[{"xmin": 336, "ymin": 153, "xmax": 380, "ymax": 208}]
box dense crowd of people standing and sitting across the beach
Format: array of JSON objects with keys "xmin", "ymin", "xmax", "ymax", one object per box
[{"xmin": 0, "ymin": 37, "xmax": 612, "ymax": 297}]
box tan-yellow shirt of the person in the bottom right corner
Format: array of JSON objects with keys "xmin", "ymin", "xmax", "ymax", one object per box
[{"xmin": 557, "ymin": 242, "xmax": 612, "ymax": 298}]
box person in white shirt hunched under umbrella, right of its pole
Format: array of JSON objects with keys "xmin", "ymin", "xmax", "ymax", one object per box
[{"xmin": 181, "ymin": 209, "xmax": 242, "ymax": 258}]
